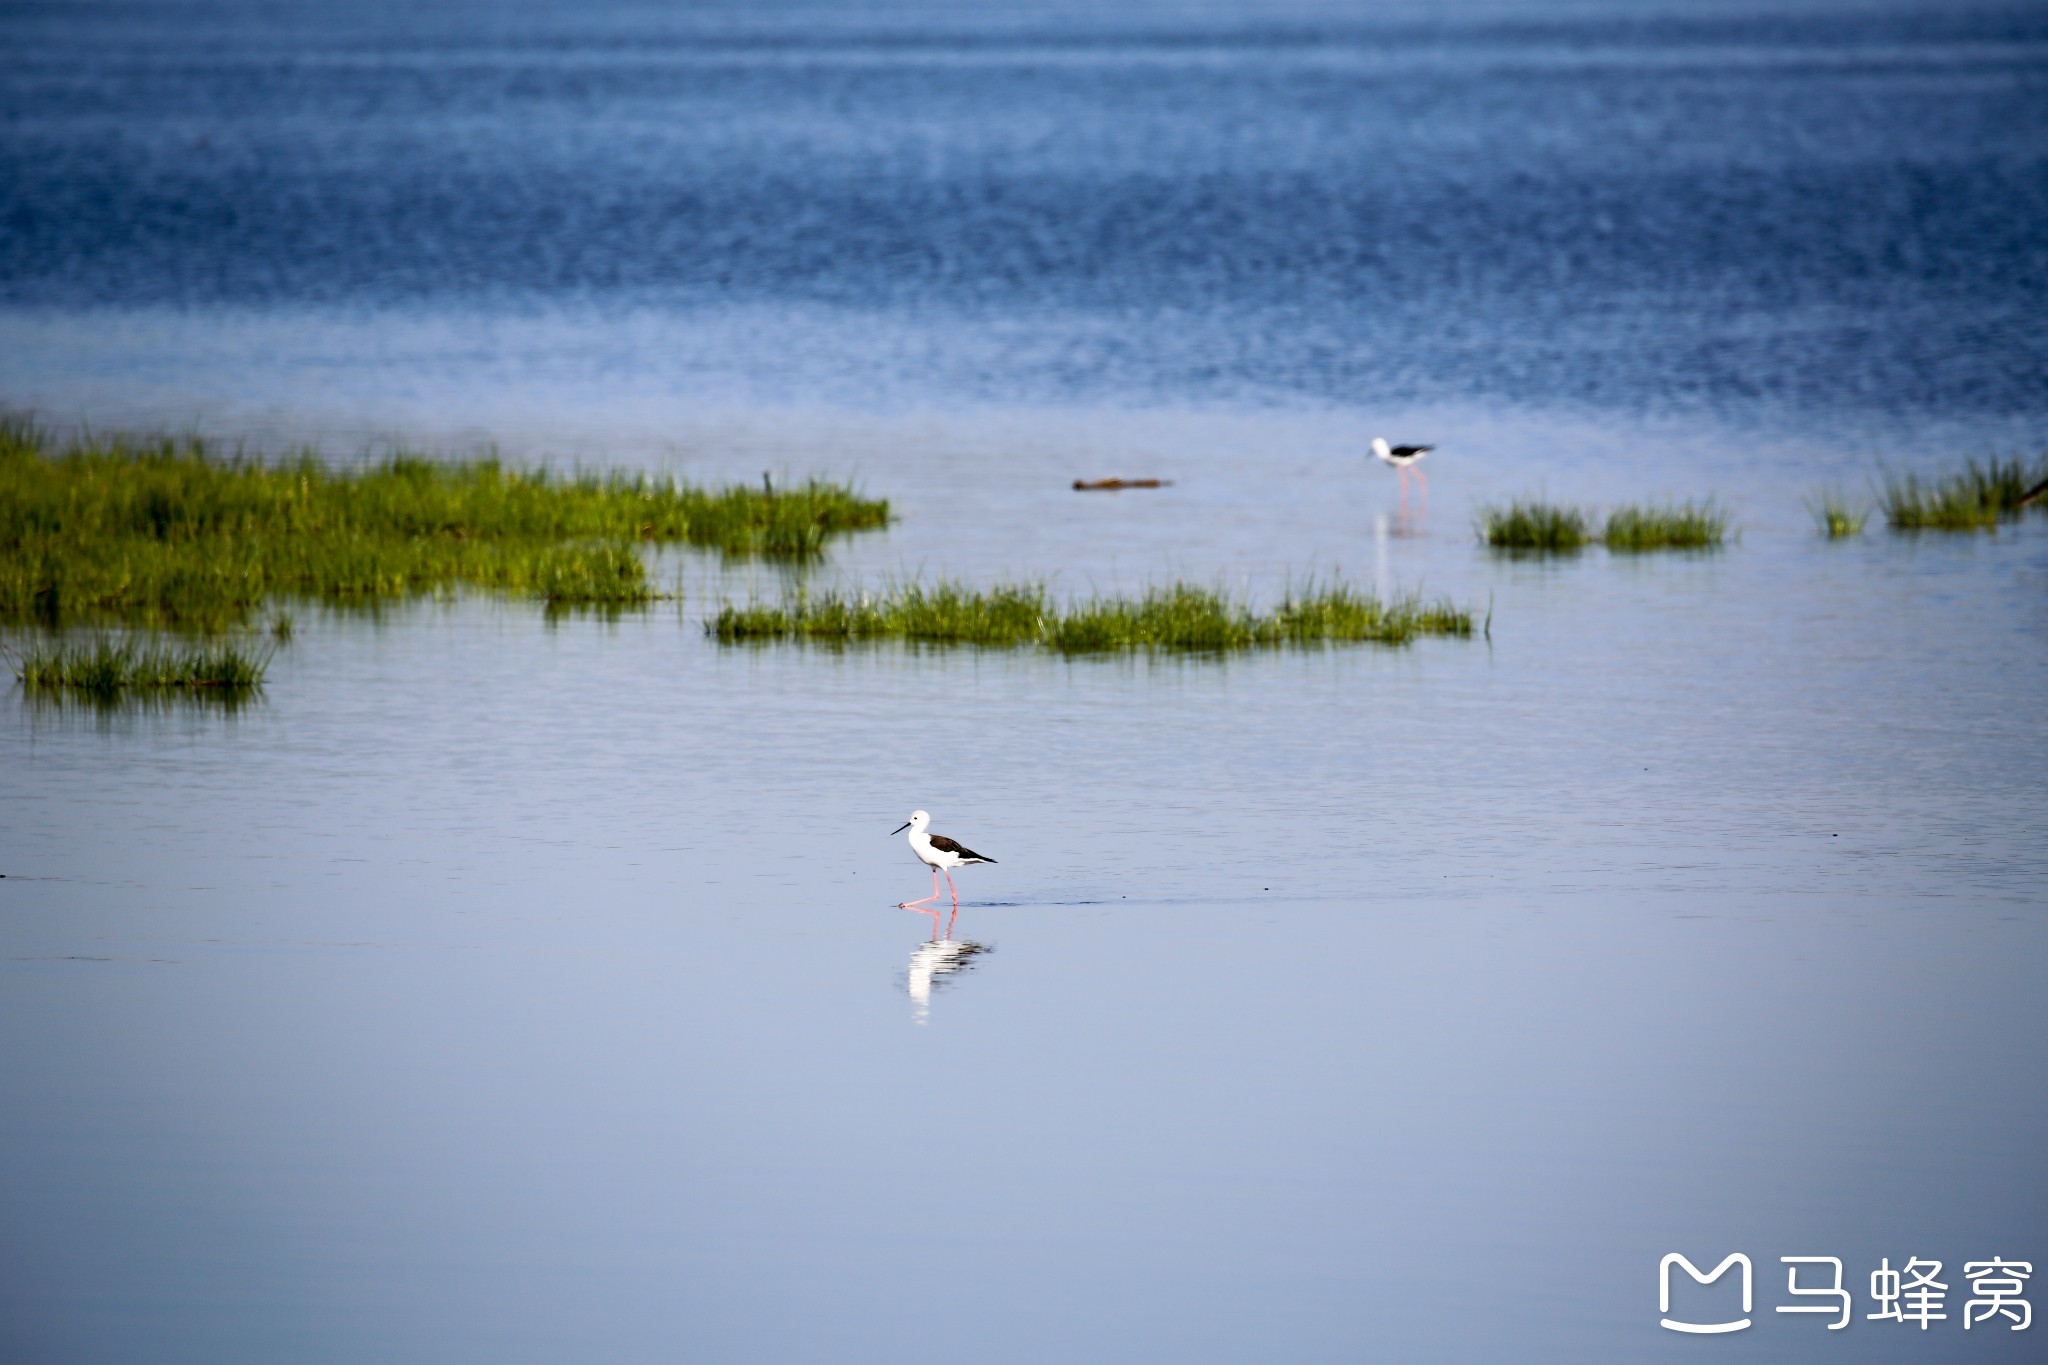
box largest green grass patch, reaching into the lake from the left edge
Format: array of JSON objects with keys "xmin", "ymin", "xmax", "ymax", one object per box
[{"xmin": 0, "ymin": 417, "xmax": 889, "ymax": 630}]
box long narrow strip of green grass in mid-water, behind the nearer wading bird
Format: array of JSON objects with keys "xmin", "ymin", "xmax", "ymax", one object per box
[{"xmin": 705, "ymin": 581, "xmax": 1473, "ymax": 653}]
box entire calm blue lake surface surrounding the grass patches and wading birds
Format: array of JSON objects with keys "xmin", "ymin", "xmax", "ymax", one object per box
[{"xmin": 0, "ymin": 0, "xmax": 2048, "ymax": 1365}]
